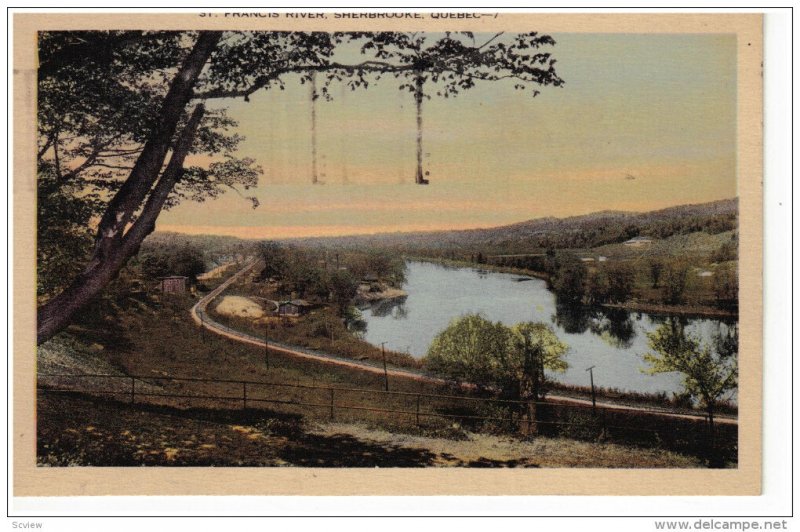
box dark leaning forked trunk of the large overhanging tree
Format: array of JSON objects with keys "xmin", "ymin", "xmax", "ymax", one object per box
[{"xmin": 36, "ymin": 32, "xmax": 221, "ymax": 344}]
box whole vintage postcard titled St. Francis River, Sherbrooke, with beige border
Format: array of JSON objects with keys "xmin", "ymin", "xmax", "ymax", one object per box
[{"xmin": 13, "ymin": 11, "xmax": 762, "ymax": 496}]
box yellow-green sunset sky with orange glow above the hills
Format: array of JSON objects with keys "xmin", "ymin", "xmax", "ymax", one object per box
[{"xmin": 157, "ymin": 34, "xmax": 737, "ymax": 239}]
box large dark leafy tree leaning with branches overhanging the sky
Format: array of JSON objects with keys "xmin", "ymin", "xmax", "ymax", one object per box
[{"xmin": 37, "ymin": 31, "xmax": 563, "ymax": 343}]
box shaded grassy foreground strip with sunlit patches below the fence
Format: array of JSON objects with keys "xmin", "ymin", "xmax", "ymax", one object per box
[{"xmin": 38, "ymin": 393, "xmax": 702, "ymax": 468}]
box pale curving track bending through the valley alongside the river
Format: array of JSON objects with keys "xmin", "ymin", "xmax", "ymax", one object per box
[{"xmin": 190, "ymin": 260, "xmax": 738, "ymax": 425}]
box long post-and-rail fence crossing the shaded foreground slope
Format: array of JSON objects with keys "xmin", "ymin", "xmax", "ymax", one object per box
[{"xmin": 38, "ymin": 374, "xmax": 738, "ymax": 460}]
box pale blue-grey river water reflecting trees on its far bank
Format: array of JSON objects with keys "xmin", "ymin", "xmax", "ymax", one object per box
[{"xmin": 362, "ymin": 261, "xmax": 727, "ymax": 393}]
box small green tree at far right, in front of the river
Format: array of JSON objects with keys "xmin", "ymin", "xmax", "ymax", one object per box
[{"xmin": 644, "ymin": 318, "xmax": 739, "ymax": 464}]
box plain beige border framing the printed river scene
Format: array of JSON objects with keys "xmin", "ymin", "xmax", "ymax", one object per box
[{"xmin": 10, "ymin": 13, "xmax": 763, "ymax": 497}]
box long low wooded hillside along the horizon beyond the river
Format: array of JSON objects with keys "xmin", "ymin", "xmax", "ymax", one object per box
[{"xmin": 292, "ymin": 199, "xmax": 738, "ymax": 254}]
